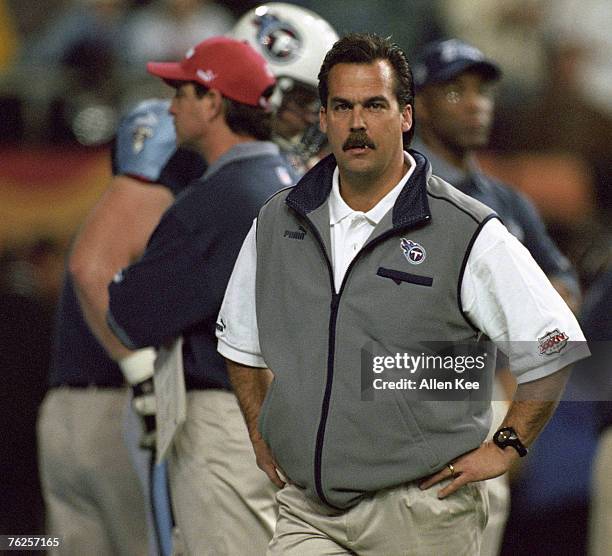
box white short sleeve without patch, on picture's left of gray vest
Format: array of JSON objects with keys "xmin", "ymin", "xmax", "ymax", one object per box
[{"xmin": 216, "ymin": 220, "xmax": 267, "ymax": 367}]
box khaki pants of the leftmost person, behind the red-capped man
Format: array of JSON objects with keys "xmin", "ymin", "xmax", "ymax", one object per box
[{"xmin": 38, "ymin": 387, "xmax": 147, "ymax": 556}]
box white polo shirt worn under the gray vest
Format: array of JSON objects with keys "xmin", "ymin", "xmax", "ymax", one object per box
[{"xmin": 217, "ymin": 153, "xmax": 589, "ymax": 383}]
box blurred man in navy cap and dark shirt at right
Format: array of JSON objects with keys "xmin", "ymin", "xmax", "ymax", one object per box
[{"xmin": 413, "ymin": 39, "xmax": 580, "ymax": 554}]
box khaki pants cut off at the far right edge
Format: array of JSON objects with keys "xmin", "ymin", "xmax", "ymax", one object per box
[{"xmin": 589, "ymin": 427, "xmax": 612, "ymax": 556}]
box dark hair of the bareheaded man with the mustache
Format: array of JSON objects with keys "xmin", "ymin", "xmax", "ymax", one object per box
[{"xmin": 319, "ymin": 33, "xmax": 414, "ymax": 145}]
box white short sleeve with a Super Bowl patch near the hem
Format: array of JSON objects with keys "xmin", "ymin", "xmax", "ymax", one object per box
[{"xmin": 461, "ymin": 219, "xmax": 590, "ymax": 383}]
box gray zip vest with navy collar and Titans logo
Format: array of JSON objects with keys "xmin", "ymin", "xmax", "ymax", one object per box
[{"xmin": 256, "ymin": 151, "xmax": 495, "ymax": 508}]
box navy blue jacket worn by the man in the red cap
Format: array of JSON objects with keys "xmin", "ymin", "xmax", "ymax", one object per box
[{"xmin": 108, "ymin": 142, "xmax": 293, "ymax": 390}]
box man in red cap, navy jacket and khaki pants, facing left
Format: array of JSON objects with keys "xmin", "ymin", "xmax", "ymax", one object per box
[{"xmin": 108, "ymin": 37, "xmax": 292, "ymax": 555}]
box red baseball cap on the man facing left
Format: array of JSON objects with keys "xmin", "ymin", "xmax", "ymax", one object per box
[{"xmin": 147, "ymin": 37, "xmax": 276, "ymax": 108}]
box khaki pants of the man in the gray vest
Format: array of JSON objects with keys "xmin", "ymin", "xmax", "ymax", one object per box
[{"xmin": 268, "ymin": 481, "xmax": 488, "ymax": 556}]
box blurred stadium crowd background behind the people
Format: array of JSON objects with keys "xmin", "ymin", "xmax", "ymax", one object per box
[{"xmin": 0, "ymin": 0, "xmax": 612, "ymax": 554}]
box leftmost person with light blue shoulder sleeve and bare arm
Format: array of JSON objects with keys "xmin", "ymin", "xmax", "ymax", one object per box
[{"xmin": 38, "ymin": 100, "xmax": 204, "ymax": 555}]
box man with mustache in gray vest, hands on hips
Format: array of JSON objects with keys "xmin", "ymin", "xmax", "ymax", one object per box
[{"xmin": 217, "ymin": 34, "xmax": 588, "ymax": 556}]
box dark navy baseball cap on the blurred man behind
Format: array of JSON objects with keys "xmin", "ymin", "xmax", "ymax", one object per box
[{"xmin": 412, "ymin": 39, "xmax": 502, "ymax": 91}]
